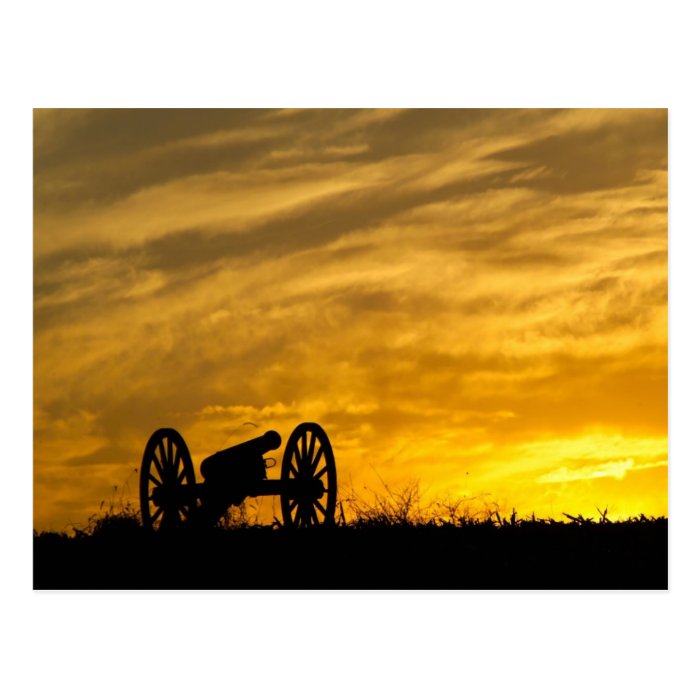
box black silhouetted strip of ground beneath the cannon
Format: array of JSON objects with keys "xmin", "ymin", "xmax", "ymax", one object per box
[{"xmin": 34, "ymin": 519, "xmax": 668, "ymax": 590}]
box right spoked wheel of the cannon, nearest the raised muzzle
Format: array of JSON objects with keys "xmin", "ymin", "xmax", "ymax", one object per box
[{"xmin": 280, "ymin": 423, "xmax": 337, "ymax": 527}]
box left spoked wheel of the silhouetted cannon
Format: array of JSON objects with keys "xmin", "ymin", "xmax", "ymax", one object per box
[{"xmin": 140, "ymin": 428, "xmax": 197, "ymax": 530}]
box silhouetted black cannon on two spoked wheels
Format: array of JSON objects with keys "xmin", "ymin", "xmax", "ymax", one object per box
[{"xmin": 139, "ymin": 423, "xmax": 337, "ymax": 530}]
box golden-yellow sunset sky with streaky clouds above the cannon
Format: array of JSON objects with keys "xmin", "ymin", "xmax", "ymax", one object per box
[{"xmin": 34, "ymin": 109, "xmax": 668, "ymax": 530}]
